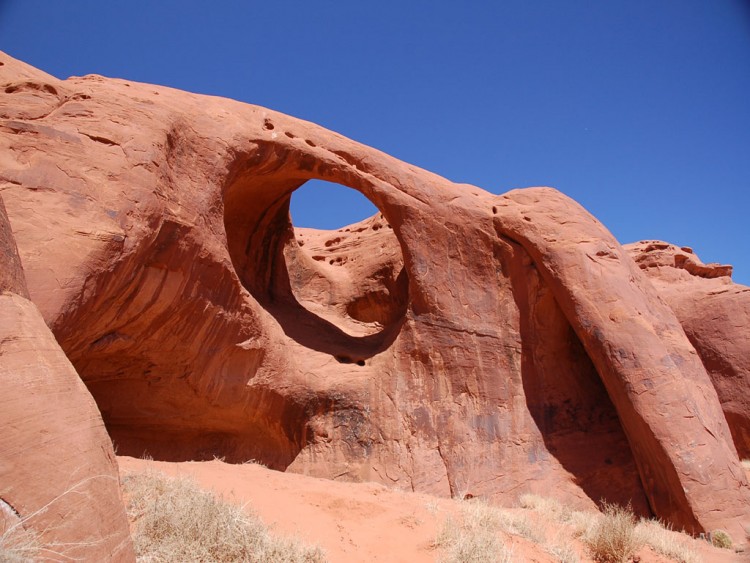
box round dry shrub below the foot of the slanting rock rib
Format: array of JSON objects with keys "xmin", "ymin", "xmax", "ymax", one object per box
[{"xmin": 583, "ymin": 503, "xmax": 640, "ymax": 563}]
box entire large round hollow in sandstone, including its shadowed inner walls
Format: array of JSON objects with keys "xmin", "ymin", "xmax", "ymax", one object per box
[{"xmin": 225, "ymin": 177, "xmax": 408, "ymax": 365}]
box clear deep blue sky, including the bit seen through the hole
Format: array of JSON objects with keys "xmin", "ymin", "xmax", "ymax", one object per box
[{"xmin": 0, "ymin": 0, "xmax": 750, "ymax": 285}]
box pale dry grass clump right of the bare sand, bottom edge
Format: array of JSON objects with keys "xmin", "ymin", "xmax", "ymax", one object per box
[{"xmin": 436, "ymin": 500, "xmax": 513, "ymax": 563}]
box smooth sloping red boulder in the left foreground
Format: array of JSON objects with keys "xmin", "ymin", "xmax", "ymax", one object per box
[{"xmin": 0, "ymin": 193, "xmax": 134, "ymax": 561}]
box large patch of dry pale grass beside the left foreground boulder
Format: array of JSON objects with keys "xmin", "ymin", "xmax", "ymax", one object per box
[{"xmin": 123, "ymin": 472, "xmax": 325, "ymax": 563}]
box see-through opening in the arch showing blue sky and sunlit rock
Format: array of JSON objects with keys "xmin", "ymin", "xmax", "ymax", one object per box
[{"xmin": 284, "ymin": 181, "xmax": 407, "ymax": 335}]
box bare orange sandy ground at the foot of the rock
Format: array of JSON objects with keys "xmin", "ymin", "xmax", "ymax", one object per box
[{"xmin": 118, "ymin": 456, "xmax": 750, "ymax": 563}]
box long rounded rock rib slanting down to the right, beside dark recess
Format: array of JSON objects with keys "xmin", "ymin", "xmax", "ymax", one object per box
[{"xmin": 493, "ymin": 193, "xmax": 750, "ymax": 537}]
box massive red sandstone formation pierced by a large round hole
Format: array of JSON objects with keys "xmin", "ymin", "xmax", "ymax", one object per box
[{"xmin": 0, "ymin": 51, "xmax": 750, "ymax": 538}]
